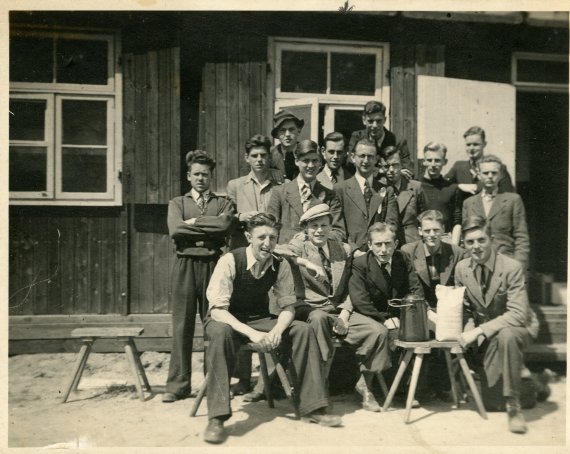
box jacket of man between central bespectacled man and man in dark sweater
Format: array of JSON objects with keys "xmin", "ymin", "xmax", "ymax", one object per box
[{"xmin": 396, "ymin": 178, "xmax": 426, "ymax": 244}]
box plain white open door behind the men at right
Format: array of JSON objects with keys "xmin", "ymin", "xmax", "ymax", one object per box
[{"xmin": 417, "ymin": 76, "xmax": 516, "ymax": 176}]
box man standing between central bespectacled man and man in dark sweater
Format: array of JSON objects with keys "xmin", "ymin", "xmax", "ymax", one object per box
[{"xmin": 380, "ymin": 146, "xmax": 426, "ymax": 245}]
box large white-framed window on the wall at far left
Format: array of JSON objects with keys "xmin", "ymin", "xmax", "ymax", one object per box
[{"xmin": 9, "ymin": 31, "xmax": 122, "ymax": 205}]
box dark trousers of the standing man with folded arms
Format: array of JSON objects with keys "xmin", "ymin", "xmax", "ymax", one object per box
[{"xmin": 166, "ymin": 256, "xmax": 218, "ymax": 396}]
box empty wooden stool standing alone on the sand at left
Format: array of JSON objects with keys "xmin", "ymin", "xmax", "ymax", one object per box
[{"xmin": 62, "ymin": 327, "xmax": 151, "ymax": 403}]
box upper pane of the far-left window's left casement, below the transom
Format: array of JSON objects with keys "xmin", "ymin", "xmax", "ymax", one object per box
[{"xmin": 9, "ymin": 99, "xmax": 47, "ymax": 140}]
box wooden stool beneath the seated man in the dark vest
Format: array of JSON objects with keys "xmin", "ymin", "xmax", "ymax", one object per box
[{"xmin": 190, "ymin": 341, "xmax": 301, "ymax": 419}]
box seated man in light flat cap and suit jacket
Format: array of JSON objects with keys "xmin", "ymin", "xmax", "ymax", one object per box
[{"xmin": 284, "ymin": 204, "xmax": 388, "ymax": 412}]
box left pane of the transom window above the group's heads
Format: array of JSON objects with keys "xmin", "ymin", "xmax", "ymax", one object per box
[{"xmin": 281, "ymin": 50, "xmax": 327, "ymax": 93}]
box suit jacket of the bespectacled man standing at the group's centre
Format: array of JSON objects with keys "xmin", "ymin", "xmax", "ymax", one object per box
[{"xmin": 334, "ymin": 177, "xmax": 398, "ymax": 249}]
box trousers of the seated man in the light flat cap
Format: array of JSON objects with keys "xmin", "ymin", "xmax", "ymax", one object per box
[{"xmin": 295, "ymin": 306, "xmax": 390, "ymax": 372}]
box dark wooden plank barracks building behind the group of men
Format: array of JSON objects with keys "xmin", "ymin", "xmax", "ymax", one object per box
[{"xmin": 8, "ymin": 11, "xmax": 569, "ymax": 360}]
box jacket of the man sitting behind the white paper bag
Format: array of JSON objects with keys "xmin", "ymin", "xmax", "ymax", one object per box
[{"xmin": 401, "ymin": 241, "xmax": 467, "ymax": 307}]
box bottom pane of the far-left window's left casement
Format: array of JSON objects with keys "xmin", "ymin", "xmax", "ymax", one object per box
[{"xmin": 10, "ymin": 146, "xmax": 47, "ymax": 191}]
